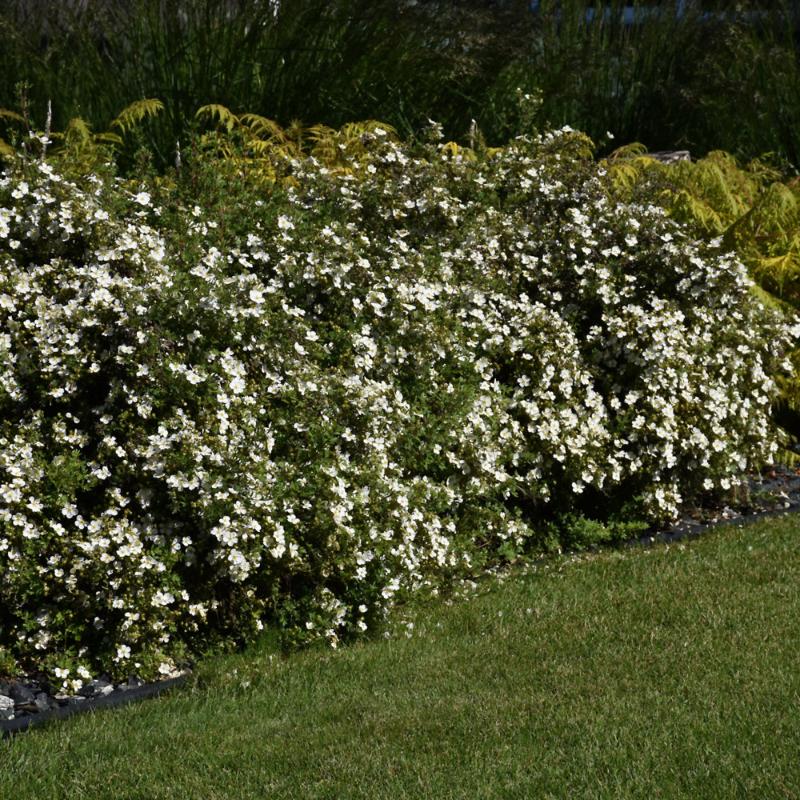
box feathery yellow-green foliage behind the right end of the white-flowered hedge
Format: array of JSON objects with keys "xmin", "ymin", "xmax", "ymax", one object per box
[{"xmin": 604, "ymin": 144, "xmax": 800, "ymax": 456}]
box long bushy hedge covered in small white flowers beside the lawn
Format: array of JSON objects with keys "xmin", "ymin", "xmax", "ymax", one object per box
[{"xmin": 0, "ymin": 129, "xmax": 788, "ymax": 688}]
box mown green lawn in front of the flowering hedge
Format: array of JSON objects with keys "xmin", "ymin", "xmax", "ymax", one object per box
[{"xmin": 0, "ymin": 516, "xmax": 800, "ymax": 800}]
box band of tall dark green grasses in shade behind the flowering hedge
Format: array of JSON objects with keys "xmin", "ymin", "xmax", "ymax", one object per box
[{"xmin": 0, "ymin": 0, "xmax": 800, "ymax": 170}]
